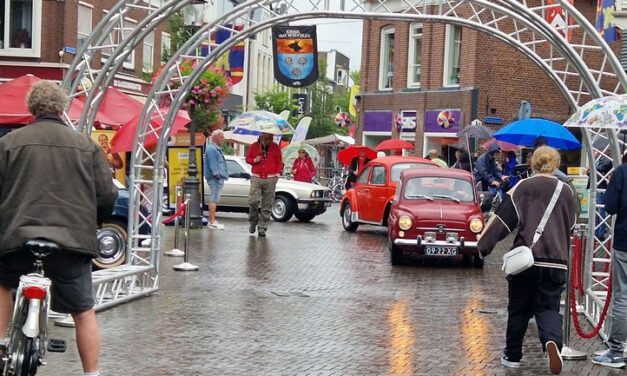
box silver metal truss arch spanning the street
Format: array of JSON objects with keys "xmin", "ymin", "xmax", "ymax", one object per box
[{"xmin": 64, "ymin": 0, "xmax": 627, "ymax": 338}]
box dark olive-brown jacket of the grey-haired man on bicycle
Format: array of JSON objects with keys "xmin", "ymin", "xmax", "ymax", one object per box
[{"xmin": 0, "ymin": 116, "xmax": 118, "ymax": 257}]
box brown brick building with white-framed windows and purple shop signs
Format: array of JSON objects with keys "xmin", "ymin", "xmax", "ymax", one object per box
[{"xmin": 356, "ymin": 1, "xmax": 620, "ymax": 160}]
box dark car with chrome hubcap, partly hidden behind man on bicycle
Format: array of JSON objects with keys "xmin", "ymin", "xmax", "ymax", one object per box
[{"xmin": 93, "ymin": 179, "xmax": 150, "ymax": 269}]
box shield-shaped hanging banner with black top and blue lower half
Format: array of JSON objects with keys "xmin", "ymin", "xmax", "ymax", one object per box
[{"xmin": 272, "ymin": 26, "xmax": 318, "ymax": 87}]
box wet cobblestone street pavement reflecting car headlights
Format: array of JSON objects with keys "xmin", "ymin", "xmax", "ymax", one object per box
[{"xmin": 40, "ymin": 206, "xmax": 625, "ymax": 375}]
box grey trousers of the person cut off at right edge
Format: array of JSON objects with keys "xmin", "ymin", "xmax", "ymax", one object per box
[{"xmin": 608, "ymin": 249, "xmax": 627, "ymax": 356}]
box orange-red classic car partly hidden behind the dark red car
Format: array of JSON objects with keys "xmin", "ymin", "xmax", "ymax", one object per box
[{"xmin": 340, "ymin": 157, "xmax": 439, "ymax": 232}]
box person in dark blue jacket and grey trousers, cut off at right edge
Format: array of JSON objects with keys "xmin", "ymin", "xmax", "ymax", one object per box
[{"xmin": 592, "ymin": 163, "xmax": 627, "ymax": 368}]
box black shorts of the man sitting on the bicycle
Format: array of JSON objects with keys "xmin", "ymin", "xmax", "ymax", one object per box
[{"xmin": 0, "ymin": 251, "xmax": 94, "ymax": 313}]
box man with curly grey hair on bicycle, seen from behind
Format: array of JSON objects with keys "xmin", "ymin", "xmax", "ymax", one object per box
[{"xmin": 0, "ymin": 81, "xmax": 117, "ymax": 376}]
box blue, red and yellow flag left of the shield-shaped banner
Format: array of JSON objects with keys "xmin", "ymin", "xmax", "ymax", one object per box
[{"xmin": 206, "ymin": 25, "xmax": 246, "ymax": 85}]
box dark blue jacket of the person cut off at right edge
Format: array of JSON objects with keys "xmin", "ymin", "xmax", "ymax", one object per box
[{"xmin": 605, "ymin": 163, "xmax": 627, "ymax": 252}]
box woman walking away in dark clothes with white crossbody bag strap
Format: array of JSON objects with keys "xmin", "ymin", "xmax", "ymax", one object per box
[{"xmin": 478, "ymin": 146, "xmax": 576, "ymax": 375}]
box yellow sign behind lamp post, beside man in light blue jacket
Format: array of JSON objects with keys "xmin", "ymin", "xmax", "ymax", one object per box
[{"xmin": 168, "ymin": 147, "xmax": 205, "ymax": 206}]
